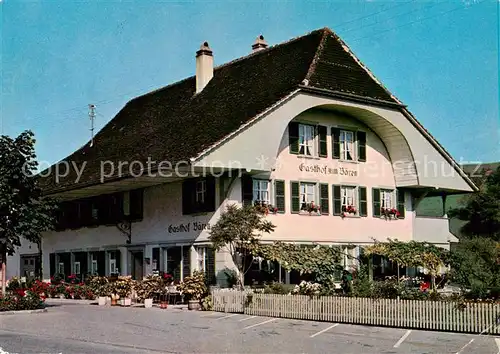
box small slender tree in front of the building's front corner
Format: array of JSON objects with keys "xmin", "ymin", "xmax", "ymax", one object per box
[{"xmin": 209, "ymin": 205, "xmax": 275, "ymax": 289}]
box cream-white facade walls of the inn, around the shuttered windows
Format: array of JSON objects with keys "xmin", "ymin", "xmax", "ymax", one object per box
[{"xmin": 37, "ymin": 111, "xmax": 456, "ymax": 283}]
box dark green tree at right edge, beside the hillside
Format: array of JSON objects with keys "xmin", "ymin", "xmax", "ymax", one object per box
[{"xmin": 448, "ymin": 167, "xmax": 500, "ymax": 241}]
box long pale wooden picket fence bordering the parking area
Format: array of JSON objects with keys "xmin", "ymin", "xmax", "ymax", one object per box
[{"xmin": 212, "ymin": 290, "xmax": 500, "ymax": 334}]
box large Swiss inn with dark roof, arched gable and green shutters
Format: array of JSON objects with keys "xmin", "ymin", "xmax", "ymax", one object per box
[{"xmin": 8, "ymin": 28, "xmax": 476, "ymax": 284}]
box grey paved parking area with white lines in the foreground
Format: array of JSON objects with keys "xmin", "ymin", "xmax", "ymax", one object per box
[{"xmin": 0, "ymin": 304, "xmax": 500, "ymax": 354}]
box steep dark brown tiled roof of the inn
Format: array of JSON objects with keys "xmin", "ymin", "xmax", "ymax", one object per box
[{"xmin": 41, "ymin": 28, "xmax": 399, "ymax": 194}]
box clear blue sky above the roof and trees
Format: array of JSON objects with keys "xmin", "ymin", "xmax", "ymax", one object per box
[{"xmin": 0, "ymin": 0, "xmax": 500, "ymax": 162}]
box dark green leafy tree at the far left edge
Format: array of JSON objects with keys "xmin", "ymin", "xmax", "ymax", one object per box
[{"xmin": 0, "ymin": 131, "xmax": 54, "ymax": 294}]
